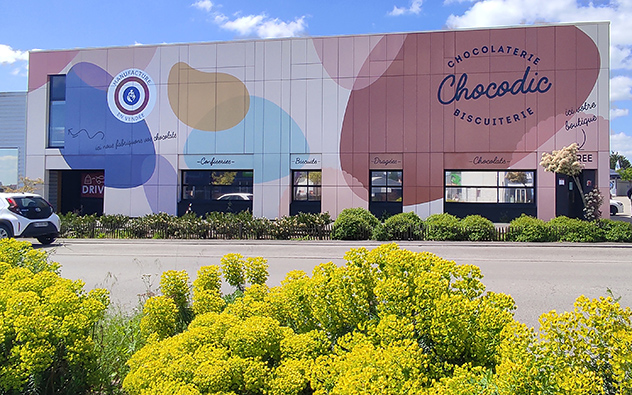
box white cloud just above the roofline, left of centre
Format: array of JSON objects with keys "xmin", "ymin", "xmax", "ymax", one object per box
[{"xmin": 192, "ymin": 0, "xmax": 308, "ymax": 38}]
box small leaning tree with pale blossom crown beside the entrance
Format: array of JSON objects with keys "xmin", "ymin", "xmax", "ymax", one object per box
[{"xmin": 540, "ymin": 143, "xmax": 599, "ymax": 220}]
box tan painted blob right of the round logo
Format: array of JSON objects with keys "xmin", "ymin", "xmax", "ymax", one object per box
[{"xmin": 168, "ymin": 62, "xmax": 250, "ymax": 132}]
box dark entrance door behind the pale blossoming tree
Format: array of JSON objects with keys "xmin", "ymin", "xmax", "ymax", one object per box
[{"xmin": 555, "ymin": 170, "xmax": 597, "ymax": 219}]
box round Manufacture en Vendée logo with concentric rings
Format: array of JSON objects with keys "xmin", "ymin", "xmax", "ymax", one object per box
[{"xmin": 108, "ymin": 69, "xmax": 156, "ymax": 123}]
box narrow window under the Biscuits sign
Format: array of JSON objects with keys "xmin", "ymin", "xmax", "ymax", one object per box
[{"xmin": 290, "ymin": 170, "xmax": 323, "ymax": 215}]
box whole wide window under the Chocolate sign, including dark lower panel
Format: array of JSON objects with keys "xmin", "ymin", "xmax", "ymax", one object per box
[{"xmin": 444, "ymin": 170, "xmax": 536, "ymax": 222}]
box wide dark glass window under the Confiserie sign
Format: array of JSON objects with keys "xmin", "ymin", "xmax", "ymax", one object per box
[{"xmin": 182, "ymin": 170, "xmax": 253, "ymax": 200}]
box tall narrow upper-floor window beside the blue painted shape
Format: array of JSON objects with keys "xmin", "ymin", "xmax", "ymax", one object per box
[{"xmin": 48, "ymin": 75, "xmax": 66, "ymax": 148}]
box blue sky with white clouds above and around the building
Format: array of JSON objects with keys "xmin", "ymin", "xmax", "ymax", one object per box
[{"xmin": 0, "ymin": 0, "xmax": 632, "ymax": 160}]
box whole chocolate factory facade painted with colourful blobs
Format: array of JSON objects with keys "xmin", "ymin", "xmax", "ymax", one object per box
[{"xmin": 27, "ymin": 23, "xmax": 609, "ymax": 221}]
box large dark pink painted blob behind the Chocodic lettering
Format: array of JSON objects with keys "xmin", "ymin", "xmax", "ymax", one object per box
[{"xmin": 340, "ymin": 26, "xmax": 601, "ymax": 205}]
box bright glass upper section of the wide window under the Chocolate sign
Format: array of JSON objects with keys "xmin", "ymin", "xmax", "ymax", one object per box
[{"xmin": 445, "ymin": 170, "xmax": 535, "ymax": 203}]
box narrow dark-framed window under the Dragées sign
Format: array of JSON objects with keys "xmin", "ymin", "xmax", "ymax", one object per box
[{"xmin": 369, "ymin": 170, "xmax": 404, "ymax": 218}]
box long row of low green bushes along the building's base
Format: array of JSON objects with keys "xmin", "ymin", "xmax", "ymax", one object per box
[{"xmin": 60, "ymin": 208, "xmax": 632, "ymax": 242}]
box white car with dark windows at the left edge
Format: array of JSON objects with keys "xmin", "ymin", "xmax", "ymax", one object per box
[{"xmin": 0, "ymin": 193, "xmax": 60, "ymax": 244}]
